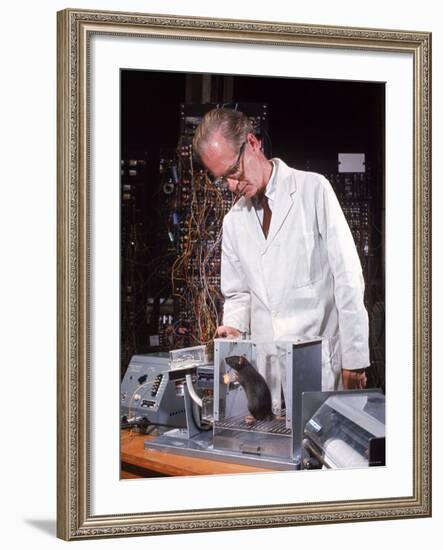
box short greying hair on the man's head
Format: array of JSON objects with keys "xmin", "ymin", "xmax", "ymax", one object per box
[{"xmin": 192, "ymin": 108, "xmax": 254, "ymax": 160}]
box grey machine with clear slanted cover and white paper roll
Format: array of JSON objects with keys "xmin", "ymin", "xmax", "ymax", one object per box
[{"xmin": 302, "ymin": 390, "xmax": 385, "ymax": 469}]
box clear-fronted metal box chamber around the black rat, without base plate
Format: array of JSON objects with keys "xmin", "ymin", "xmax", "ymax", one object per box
[{"xmin": 214, "ymin": 339, "xmax": 321, "ymax": 467}]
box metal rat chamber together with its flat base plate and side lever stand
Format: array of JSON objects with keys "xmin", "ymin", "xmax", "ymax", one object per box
[{"xmin": 145, "ymin": 339, "xmax": 322, "ymax": 470}]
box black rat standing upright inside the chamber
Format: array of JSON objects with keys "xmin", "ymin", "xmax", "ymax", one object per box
[{"xmin": 225, "ymin": 355, "xmax": 274, "ymax": 420}]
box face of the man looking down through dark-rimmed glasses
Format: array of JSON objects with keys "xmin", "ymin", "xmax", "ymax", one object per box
[{"xmin": 200, "ymin": 132, "xmax": 266, "ymax": 198}]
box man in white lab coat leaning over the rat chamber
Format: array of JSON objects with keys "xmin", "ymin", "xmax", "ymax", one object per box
[{"xmin": 193, "ymin": 109, "xmax": 369, "ymax": 394}]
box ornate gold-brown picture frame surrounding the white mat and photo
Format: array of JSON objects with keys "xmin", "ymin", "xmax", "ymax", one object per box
[{"xmin": 57, "ymin": 9, "xmax": 431, "ymax": 540}]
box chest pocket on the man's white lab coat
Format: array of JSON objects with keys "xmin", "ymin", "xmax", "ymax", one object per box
[{"xmin": 292, "ymin": 231, "xmax": 322, "ymax": 288}]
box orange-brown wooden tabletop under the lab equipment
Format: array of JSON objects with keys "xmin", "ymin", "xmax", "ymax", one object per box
[{"xmin": 121, "ymin": 430, "xmax": 271, "ymax": 479}]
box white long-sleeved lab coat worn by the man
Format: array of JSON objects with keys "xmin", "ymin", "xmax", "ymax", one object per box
[{"xmin": 221, "ymin": 159, "xmax": 369, "ymax": 390}]
